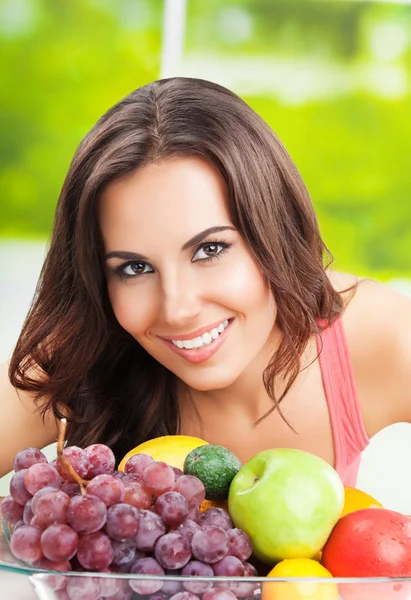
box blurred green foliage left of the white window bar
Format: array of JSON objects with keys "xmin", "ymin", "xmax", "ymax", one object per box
[{"xmin": 0, "ymin": 0, "xmax": 162, "ymax": 237}]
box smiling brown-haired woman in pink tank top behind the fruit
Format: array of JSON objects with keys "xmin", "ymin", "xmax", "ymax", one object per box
[{"xmin": 0, "ymin": 78, "xmax": 411, "ymax": 485}]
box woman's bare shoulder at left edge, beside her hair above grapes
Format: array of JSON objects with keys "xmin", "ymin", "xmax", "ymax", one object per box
[{"xmin": 0, "ymin": 363, "xmax": 57, "ymax": 477}]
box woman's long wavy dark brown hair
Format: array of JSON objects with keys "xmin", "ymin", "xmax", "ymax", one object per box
[{"xmin": 9, "ymin": 78, "xmax": 342, "ymax": 459}]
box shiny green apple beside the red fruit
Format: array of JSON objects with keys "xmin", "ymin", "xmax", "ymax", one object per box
[{"xmin": 228, "ymin": 448, "xmax": 344, "ymax": 564}]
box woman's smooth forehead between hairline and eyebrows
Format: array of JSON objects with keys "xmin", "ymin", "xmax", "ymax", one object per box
[{"xmin": 99, "ymin": 157, "xmax": 231, "ymax": 247}]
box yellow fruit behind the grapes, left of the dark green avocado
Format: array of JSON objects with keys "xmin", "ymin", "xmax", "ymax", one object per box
[{"xmin": 118, "ymin": 435, "xmax": 208, "ymax": 471}]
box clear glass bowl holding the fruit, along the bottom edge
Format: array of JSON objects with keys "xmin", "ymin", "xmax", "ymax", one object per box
[{"xmin": 0, "ymin": 516, "xmax": 411, "ymax": 600}]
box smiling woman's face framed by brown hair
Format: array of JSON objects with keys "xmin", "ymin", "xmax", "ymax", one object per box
[{"xmin": 99, "ymin": 158, "xmax": 276, "ymax": 391}]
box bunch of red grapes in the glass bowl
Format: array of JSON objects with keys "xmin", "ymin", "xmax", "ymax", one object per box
[{"xmin": 1, "ymin": 444, "xmax": 259, "ymax": 600}]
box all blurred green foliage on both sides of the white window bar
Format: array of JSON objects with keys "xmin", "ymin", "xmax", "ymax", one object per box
[{"xmin": 0, "ymin": 0, "xmax": 411, "ymax": 278}]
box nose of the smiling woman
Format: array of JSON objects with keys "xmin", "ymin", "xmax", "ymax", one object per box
[{"xmin": 162, "ymin": 278, "xmax": 201, "ymax": 328}]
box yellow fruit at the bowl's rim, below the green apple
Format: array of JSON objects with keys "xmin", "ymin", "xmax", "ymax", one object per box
[{"xmin": 262, "ymin": 558, "xmax": 338, "ymax": 600}]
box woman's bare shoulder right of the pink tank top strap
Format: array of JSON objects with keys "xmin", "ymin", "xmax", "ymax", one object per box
[{"xmin": 330, "ymin": 274, "xmax": 411, "ymax": 436}]
